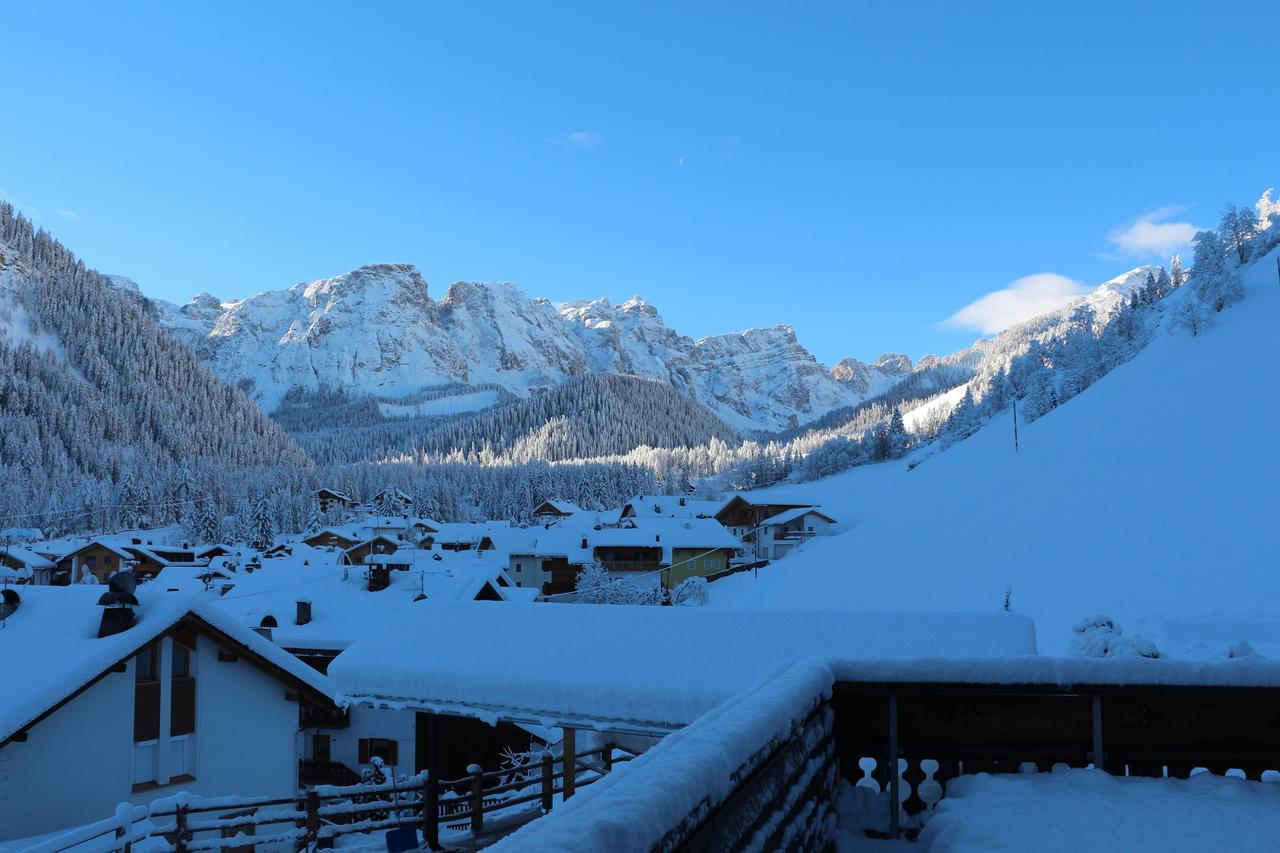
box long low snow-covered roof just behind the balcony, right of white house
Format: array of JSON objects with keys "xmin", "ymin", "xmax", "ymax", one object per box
[{"xmin": 329, "ymin": 601, "xmax": 1036, "ymax": 729}]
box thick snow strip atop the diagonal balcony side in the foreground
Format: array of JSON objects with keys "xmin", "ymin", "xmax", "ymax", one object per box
[{"xmin": 490, "ymin": 661, "xmax": 832, "ymax": 853}]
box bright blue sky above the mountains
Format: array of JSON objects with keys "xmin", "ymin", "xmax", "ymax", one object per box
[{"xmin": 0, "ymin": 1, "xmax": 1280, "ymax": 364}]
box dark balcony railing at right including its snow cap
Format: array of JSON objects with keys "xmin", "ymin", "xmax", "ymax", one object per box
[{"xmin": 832, "ymin": 658, "xmax": 1280, "ymax": 833}]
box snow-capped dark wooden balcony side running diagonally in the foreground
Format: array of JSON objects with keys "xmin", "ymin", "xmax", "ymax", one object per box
[{"xmin": 492, "ymin": 661, "xmax": 837, "ymax": 853}]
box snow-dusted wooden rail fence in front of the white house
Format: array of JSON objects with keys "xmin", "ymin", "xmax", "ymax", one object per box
[{"xmin": 32, "ymin": 744, "xmax": 635, "ymax": 853}]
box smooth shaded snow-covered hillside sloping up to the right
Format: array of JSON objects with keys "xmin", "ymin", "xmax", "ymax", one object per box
[{"xmin": 713, "ymin": 251, "xmax": 1280, "ymax": 657}]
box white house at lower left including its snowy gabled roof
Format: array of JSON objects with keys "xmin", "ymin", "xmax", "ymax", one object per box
[{"xmin": 0, "ymin": 585, "xmax": 337, "ymax": 845}]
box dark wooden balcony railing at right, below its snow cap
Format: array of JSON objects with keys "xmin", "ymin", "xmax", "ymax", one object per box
[{"xmin": 832, "ymin": 681, "xmax": 1280, "ymax": 834}]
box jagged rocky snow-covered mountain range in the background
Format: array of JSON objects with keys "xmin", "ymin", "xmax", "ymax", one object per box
[{"xmin": 157, "ymin": 264, "xmax": 910, "ymax": 432}]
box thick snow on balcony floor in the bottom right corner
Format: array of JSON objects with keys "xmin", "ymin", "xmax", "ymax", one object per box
[{"xmin": 920, "ymin": 770, "xmax": 1280, "ymax": 853}]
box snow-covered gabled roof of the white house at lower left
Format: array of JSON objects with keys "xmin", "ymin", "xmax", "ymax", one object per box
[{"xmin": 0, "ymin": 584, "xmax": 334, "ymax": 742}]
